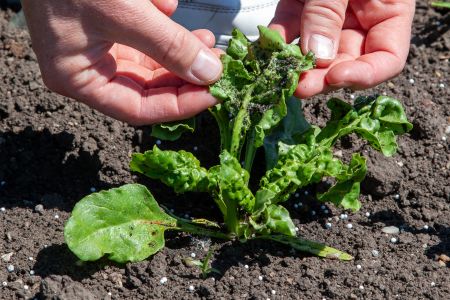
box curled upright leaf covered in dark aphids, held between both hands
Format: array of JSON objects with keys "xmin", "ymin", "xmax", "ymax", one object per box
[{"xmin": 210, "ymin": 26, "xmax": 314, "ymax": 164}]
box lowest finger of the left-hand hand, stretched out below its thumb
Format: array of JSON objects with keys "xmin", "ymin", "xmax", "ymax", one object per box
[{"xmin": 78, "ymin": 56, "xmax": 217, "ymax": 125}]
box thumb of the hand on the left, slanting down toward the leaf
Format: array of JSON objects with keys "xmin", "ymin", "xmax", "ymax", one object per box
[{"xmin": 103, "ymin": 0, "xmax": 222, "ymax": 85}]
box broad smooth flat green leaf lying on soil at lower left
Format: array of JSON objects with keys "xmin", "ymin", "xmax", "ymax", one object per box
[{"xmin": 64, "ymin": 184, "xmax": 176, "ymax": 263}]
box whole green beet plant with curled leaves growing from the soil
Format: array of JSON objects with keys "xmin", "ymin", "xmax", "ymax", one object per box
[{"xmin": 64, "ymin": 26, "xmax": 412, "ymax": 262}]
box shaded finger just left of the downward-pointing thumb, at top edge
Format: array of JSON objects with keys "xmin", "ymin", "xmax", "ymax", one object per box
[{"xmin": 269, "ymin": 0, "xmax": 303, "ymax": 43}]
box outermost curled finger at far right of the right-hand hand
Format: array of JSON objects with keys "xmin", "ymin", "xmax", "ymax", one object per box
[{"xmin": 327, "ymin": 15, "xmax": 411, "ymax": 89}]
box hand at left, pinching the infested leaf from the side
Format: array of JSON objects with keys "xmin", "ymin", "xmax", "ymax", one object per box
[{"xmin": 22, "ymin": 0, "xmax": 222, "ymax": 125}]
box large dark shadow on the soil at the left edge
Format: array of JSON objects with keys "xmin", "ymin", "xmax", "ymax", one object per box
[{"xmin": 0, "ymin": 127, "xmax": 107, "ymax": 211}]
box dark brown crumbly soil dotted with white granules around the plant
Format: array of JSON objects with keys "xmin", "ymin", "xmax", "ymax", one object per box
[{"xmin": 0, "ymin": 1, "xmax": 450, "ymax": 299}]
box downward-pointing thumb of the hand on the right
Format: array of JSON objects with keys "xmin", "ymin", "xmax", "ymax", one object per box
[{"xmin": 300, "ymin": 0, "xmax": 348, "ymax": 67}]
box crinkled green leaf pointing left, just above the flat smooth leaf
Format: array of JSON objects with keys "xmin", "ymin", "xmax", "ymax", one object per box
[{"xmin": 130, "ymin": 146, "xmax": 215, "ymax": 193}]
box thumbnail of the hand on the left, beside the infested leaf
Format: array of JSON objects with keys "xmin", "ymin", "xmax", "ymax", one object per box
[{"xmin": 191, "ymin": 50, "xmax": 222, "ymax": 83}]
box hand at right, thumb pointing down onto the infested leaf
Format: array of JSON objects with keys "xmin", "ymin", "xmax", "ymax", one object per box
[{"xmin": 270, "ymin": 0, "xmax": 415, "ymax": 98}]
